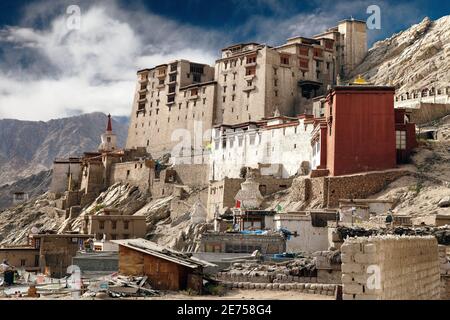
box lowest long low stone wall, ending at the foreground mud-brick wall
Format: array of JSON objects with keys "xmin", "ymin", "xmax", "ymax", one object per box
[{"xmin": 223, "ymin": 282, "xmax": 337, "ymax": 296}]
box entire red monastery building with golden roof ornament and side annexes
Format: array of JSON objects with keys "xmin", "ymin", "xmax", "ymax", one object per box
[{"xmin": 312, "ymin": 79, "xmax": 416, "ymax": 176}]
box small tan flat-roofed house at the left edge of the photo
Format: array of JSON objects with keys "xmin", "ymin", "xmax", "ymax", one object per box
[{"xmin": 0, "ymin": 246, "xmax": 40, "ymax": 272}]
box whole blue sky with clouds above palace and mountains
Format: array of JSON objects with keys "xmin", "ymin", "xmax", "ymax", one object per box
[{"xmin": 0, "ymin": 0, "xmax": 450, "ymax": 121}]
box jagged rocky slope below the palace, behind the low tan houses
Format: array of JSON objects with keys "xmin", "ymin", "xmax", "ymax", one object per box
[{"xmin": 0, "ymin": 184, "xmax": 207, "ymax": 251}]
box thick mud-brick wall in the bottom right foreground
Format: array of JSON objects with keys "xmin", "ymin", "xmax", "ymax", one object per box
[{"xmin": 341, "ymin": 236, "xmax": 441, "ymax": 300}]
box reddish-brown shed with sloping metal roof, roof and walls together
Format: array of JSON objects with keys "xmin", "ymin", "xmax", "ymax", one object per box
[{"xmin": 113, "ymin": 239, "xmax": 215, "ymax": 292}]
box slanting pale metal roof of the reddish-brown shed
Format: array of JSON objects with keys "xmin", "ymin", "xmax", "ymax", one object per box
[{"xmin": 111, "ymin": 239, "xmax": 216, "ymax": 269}]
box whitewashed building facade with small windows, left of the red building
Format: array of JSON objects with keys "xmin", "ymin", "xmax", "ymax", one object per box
[{"xmin": 210, "ymin": 116, "xmax": 314, "ymax": 181}]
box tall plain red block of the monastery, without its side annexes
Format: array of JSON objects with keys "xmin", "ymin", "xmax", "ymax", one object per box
[{"xmin": 327, "ymin": 86, "xmax": 396, "ymax": 176}]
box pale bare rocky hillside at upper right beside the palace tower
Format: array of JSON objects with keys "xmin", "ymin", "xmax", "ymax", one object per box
[{"xmin": 349, "ymin": 16, "xmax": 450, "ymax": 93}]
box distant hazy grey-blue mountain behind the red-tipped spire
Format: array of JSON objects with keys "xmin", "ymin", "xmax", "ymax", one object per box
[{"xmin": 0, "ymin": 112, "xmax": 128, "ymax": 186}]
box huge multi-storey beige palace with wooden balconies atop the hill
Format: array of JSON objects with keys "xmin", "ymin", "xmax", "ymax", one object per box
[{"xmin": 126, "ymin": 19, "xmax": 367, "ymax": 157}]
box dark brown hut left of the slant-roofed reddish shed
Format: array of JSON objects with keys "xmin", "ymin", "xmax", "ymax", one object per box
[{"xmin": 29, "ymin": 234, "xmax": 93, "ymax": 278}]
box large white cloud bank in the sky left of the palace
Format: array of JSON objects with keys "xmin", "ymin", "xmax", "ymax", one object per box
[{"xmin": 0, "ymin": 2, "xmax": 224, "ymax": 120}]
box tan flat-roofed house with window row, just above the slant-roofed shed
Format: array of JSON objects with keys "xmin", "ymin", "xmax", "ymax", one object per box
[{"xmin": 82, "ymin": 208, "xmax": 147, "ymax": 240}]
